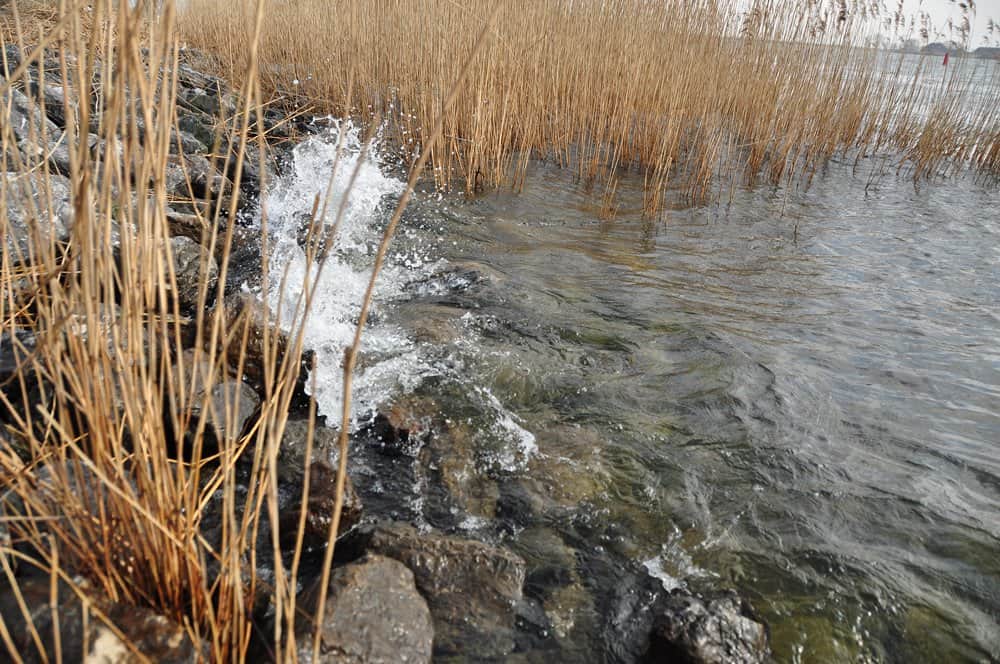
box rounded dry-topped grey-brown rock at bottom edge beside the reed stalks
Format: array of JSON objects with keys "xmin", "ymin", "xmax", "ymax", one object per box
[{"xmin": 303, "ymin": 555, "xmax": 434, "ymax": 664}]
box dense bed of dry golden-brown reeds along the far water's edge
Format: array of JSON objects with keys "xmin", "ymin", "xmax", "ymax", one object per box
[{"xmin": 179, "ymin": 0, "xmax": 1000, "ymax": 212}]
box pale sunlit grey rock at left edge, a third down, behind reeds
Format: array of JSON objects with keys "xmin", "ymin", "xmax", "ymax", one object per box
[{"xmin": 0, "ymin": 173, "xmax": 73, "ymax": 260}]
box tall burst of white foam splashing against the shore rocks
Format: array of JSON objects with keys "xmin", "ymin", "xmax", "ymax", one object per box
[{"xmin": 264, "ymin": 121, "xmax": 427, "ymax": 421}]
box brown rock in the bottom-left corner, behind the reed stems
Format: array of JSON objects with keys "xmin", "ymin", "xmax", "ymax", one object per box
[{"xmin": 0, "ymin": 577, "xmax": 201, "ymax": 664}]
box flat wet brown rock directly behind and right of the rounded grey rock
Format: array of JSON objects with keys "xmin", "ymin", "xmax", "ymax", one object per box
[{"xmin": 348, "ymin": 523, "xmax": 525, "ymax": 659}]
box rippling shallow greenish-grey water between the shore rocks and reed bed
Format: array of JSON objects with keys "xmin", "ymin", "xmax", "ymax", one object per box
[{"xmin": 260, "ymin": 123, "xmax": 1000, "ymax": 662}]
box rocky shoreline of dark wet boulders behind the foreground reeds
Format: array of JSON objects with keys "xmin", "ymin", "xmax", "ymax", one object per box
[{"xmin": 0, "ymin": 47, "xmax": 769, "ymax": 663}]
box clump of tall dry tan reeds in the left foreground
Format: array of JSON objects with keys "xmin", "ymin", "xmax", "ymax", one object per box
[{"xmin": 0, "ymin": 0, "xmax": 478, "ymax": 661}]
